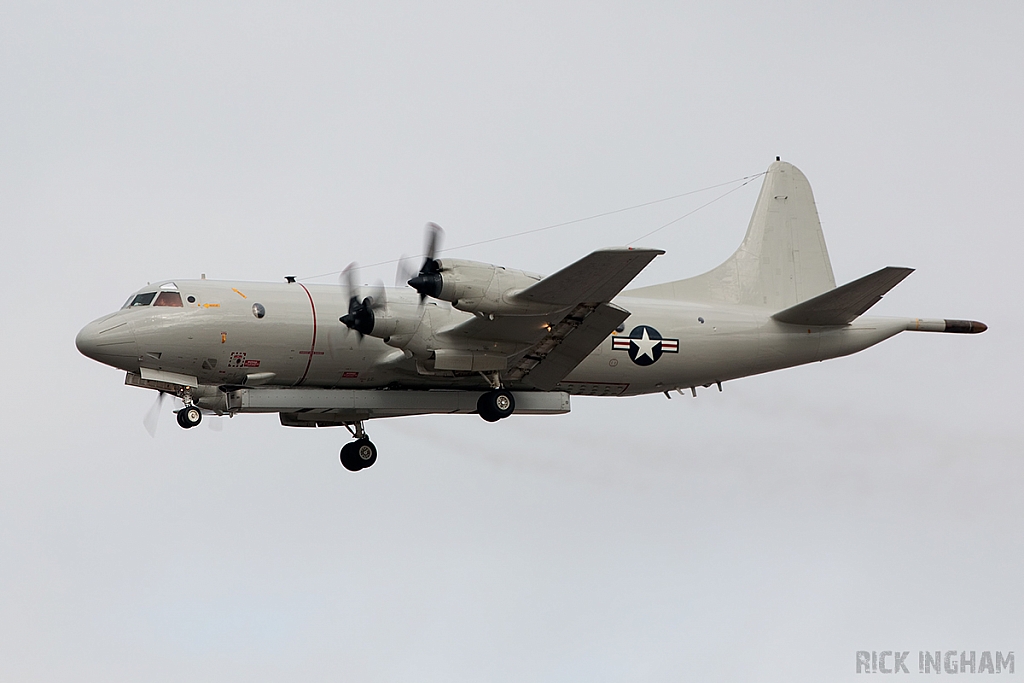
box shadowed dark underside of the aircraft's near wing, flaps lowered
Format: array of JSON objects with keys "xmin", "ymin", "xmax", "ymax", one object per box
[{"xmin": 443, "ymin": 247, "xmax": 665, "ymax": 390}]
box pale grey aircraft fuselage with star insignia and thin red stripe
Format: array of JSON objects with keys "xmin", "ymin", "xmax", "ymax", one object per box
[{"xmin": 77, "ymin": 280, "xmax": 910, "ymax": 395}]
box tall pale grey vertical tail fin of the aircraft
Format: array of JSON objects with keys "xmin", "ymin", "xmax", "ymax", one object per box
[{"xmin": 626, "ymin": 161, "xmax": 836, "ymax": 310}]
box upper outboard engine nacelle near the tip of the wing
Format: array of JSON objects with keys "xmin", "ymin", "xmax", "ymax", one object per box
[{"xmin": 409, "ymin": 258, "xmax": 551, "ymax": 315}]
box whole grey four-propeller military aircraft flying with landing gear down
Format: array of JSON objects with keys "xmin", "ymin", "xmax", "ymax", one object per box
[{"xmin": 76, "ymin": 161, "xmax": 986, "ymax": 471}]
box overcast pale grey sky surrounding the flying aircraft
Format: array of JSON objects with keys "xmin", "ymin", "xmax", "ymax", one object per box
[{"xmin": 0, "ymin": 0, "xmax": 1024, "ymax": 683}]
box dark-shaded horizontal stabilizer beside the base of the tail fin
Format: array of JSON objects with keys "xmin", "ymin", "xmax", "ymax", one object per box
[{"xmin": 772, "ymin": 265, "xmax": 913, "ymax": 326}]
